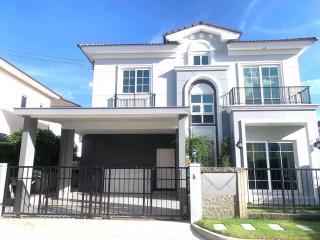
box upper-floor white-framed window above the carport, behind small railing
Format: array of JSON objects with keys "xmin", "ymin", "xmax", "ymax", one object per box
[{"xmin": 123, "ymin": 69, "xmax": 150, "ymax": 93}]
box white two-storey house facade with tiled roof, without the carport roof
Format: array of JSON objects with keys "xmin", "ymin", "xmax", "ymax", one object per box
[{"xmin": 74, "ymin": 22, "xmax": 320, "ymax": 171}]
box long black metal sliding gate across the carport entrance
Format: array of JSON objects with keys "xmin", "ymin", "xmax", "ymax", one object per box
[{"xmin": 3, "ymin": 166, "xmax": 189, "ymax": 218}]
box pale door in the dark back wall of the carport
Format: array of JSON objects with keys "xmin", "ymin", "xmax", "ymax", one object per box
[{"xmin": 157, "ymin": 148, "xmax": 175, "ymax": 190}]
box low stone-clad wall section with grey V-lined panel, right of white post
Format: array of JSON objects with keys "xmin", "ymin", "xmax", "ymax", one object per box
[{"xmin": 201, "ymin": 168, "xmax": 246, "ymax": 218}]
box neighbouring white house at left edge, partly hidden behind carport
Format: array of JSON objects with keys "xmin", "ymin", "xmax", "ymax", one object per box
[{"xmin": 0, "ymin": 58, "xmax": 79, "ymax": 154}]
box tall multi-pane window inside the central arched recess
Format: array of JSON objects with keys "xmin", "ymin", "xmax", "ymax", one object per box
[{"xmin": 190, "ymin": 84, "xmax": 215, "ymax": 125}]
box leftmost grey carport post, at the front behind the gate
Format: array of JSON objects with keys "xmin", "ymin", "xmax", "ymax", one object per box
[{"xmin": 15, "ymin": 117, "xmax": 38, "ymax": 214}]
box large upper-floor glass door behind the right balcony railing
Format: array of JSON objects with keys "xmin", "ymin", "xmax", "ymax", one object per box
[{"xmin": 243, "ymin": 66, "xmax": 281, "ymax": 104}]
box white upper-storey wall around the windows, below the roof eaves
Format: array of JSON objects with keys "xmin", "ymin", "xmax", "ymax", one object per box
[{"xmin": 92, "ymin": 32, "xmax": 308, "ymax": 107}]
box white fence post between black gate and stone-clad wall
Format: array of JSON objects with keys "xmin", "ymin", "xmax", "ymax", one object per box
[{"xmin": 189, "ymin": 163, "xmax": 202, "ymax": 223}]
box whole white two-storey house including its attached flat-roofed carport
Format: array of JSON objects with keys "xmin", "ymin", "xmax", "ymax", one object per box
[{"xmin": 4, "ymin": 22, "xmax": 320, "ymax": 218}]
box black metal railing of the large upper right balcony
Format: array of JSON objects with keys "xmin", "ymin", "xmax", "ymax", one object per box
[{"xmin": 221, "ymin": 86, "xmax": 311, "ymax": 107}]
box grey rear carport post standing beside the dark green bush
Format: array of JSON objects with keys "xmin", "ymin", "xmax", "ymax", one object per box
[{"xmin": 58, "ymin": 129, "xmax": 75, "ymax": 198}]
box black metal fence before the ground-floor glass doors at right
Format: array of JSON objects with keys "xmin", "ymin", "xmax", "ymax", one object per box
[{"xmin": 245, "ymin": 168, "xmax": 320, "ymax": 213}]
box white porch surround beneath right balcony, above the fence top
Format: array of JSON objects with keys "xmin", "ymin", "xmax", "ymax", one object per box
[{"xmin": 232, "ymin": 110, "xmax": 320, "ymax": 168}]
